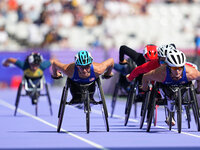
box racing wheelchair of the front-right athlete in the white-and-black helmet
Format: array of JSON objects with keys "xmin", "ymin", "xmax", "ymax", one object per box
[{"xmin": 147, "ymin": 82, "xmax": 200, "ymax": 133}]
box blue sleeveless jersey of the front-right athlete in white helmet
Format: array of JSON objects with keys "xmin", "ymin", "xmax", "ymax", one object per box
[{"xmin": 162, "ymin": 66, "xmax": 188, "ymax": 85}]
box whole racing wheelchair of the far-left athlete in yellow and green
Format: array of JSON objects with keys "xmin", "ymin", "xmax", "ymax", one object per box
[{"xmin": 14, "ymin": 76, "xmax": 53, "ymax": 116}]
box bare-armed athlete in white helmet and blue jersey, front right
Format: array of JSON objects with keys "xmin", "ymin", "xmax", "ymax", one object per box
[{"xmin": 142, "ymin": 48, "xmax": 200, "ymax": 125}]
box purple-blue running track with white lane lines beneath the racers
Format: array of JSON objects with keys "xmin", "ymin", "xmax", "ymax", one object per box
[{"xmin": 0, "ymin": 88, "xmax": 200, "ymax": 150}]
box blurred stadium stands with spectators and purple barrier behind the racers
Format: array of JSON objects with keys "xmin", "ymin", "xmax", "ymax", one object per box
[{"xmin": 0, "ymin": 0, "xmax": 200, "ymax": 93}]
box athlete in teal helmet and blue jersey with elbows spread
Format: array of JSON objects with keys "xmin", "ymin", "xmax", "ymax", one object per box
[{"xmin": 51, "ymin": 50, "xmax": 114, "ymax": 104}]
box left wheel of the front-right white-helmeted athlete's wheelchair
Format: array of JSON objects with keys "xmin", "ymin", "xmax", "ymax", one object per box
[{"xmin": 147, "ymin": 88, "xmax": 157, "ymax": 132}]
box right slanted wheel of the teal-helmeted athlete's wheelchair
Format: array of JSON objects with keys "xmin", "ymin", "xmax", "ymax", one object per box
[{"xmin": 97, "ymin": 79, "xmax": 110, "ymax": 132}]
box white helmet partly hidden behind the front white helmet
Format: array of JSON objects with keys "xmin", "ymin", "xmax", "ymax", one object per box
[{"xmin": 157, "ymin": 44, "xmax": 176, "ymax": 57}]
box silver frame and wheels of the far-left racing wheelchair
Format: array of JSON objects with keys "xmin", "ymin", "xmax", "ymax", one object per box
[{"xmin": 14, "ymin": 76, "xmax": 53, "ymax": 116}]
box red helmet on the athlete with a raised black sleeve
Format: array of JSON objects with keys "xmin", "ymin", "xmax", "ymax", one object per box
[{"xmin": 143, "ymin": 44, "xmax": 158, "ymax": 60}]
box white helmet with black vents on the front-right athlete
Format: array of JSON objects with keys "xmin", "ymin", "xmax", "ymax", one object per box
[{"xmin": 166, "ymin": 49, "xmax": 186, "ymax": 67}]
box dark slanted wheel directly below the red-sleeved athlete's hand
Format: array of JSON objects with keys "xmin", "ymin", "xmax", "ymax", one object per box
[{"xmin": 124, "ymin": 83, "xmax": 136, "ymax": 126}]
